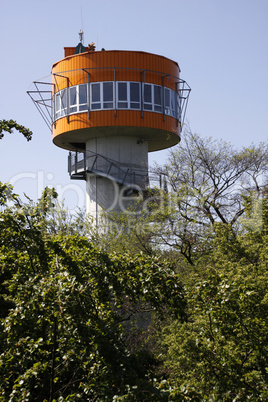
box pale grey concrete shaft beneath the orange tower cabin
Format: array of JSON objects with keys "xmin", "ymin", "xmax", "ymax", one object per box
[{"xmin": 86, "ymin": 135, "xmax": 148, "ymax": 219}]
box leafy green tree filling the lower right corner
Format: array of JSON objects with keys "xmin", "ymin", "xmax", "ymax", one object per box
[{"xmin": 159, "ymin": 197, "xmax": 268, "ymax": 401}]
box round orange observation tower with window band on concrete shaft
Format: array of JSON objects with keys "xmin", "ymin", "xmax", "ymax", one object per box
[{"xmin": 28, "ymin": 32, "xmax": 190, "ymax": 218}]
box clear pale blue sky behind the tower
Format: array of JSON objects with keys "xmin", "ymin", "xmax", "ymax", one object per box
[{"xmin": 0, "ymin": 0, "xmax": 268, "ymax": 209}]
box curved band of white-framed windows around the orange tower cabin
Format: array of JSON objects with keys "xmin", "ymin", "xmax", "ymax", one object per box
[{"xmin": 53, "ymin": 81, "xmax": 181, "ymax": 121}]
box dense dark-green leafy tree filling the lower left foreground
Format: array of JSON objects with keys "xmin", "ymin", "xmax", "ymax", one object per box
[{"xmin": 0, "ymin": 185, "xmax": 185, "ymax": 401}]
